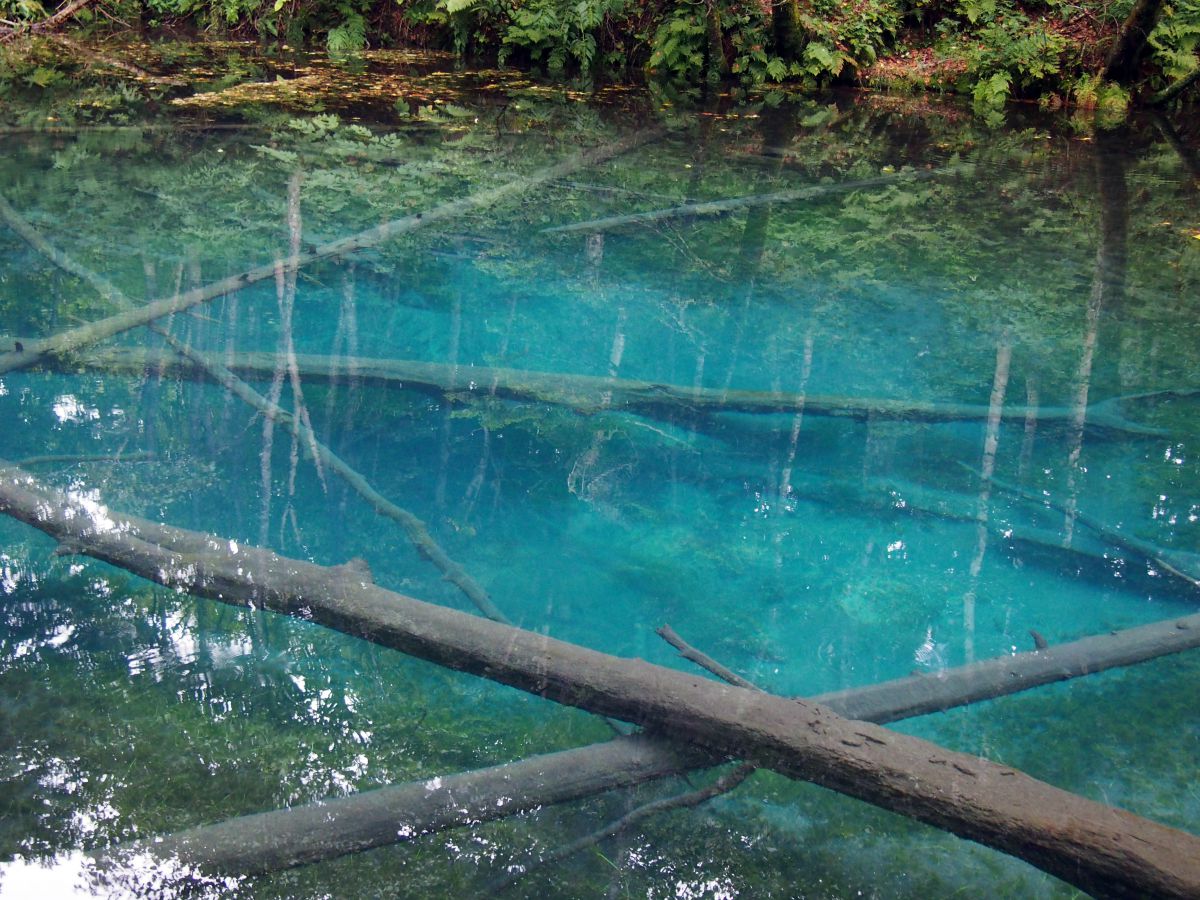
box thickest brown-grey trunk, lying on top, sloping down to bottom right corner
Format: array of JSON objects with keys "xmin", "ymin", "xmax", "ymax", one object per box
[{"xmin": 0, "ymin": 464, "xmax": 1200, "ymax": 898}]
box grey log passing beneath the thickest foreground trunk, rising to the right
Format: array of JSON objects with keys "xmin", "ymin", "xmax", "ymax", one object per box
[{"xmin": 110, "ymin": 613, "xmax": 1200, "ymax": 876}]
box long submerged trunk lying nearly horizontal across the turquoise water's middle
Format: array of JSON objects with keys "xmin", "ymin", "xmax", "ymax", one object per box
[{"xmin": 51, "ymin": 348, "xmax": 1166, "ymax": 436}]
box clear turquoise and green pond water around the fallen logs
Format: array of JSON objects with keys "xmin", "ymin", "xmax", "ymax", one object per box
[{"xmin": 0, "ymin": 42, "xmax": 1200, "ymax": 898}]
